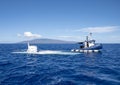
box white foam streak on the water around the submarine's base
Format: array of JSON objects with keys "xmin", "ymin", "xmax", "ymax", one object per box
[{"xmin": 12, "ymin": 50, "xmax": 80, "ymax": 55}]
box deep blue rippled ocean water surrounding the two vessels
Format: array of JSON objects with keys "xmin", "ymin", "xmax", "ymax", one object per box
[{"xmin": 0, "ymin": 44, "xmax": 120, "ymax": 85}]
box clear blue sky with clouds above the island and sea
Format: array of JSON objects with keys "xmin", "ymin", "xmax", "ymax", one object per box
[{"xmin": 0, "ymin": 0, "xmax": 120, "ymax": 43}]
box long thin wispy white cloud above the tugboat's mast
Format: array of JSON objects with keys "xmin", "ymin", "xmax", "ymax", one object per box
[{"xmin": 76, "ymin": 26, "xmax": 119, "ymax": 33}]
